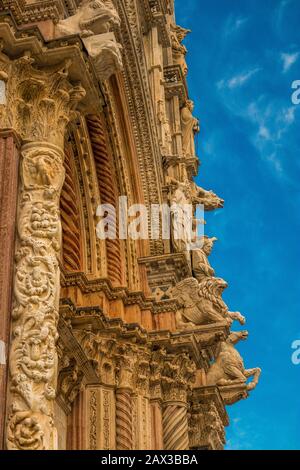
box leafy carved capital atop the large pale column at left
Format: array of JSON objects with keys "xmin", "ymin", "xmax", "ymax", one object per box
[{"xmin": 0, "ymin": 52, "xmax": 85, "ymax": 149}]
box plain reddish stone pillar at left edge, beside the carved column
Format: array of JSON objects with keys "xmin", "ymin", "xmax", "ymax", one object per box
[{"xmin": 0, "ymin": 130, "xmax": 20, "ymax": 449}]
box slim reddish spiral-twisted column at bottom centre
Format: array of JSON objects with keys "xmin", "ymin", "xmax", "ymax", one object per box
[{"xmin": 116, "ymin": 352, "xmax": 135, "ymax": 450}]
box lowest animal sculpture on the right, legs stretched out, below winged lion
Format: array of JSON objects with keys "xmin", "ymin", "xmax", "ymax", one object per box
[{"xmin": 207, "ymin": 331, "xmax": 261, "ymax": 391}]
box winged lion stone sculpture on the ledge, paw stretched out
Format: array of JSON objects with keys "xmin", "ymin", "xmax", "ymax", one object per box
[{"xmin": 172, "ymin": 277, "xmax": 245, "ymax": 329}]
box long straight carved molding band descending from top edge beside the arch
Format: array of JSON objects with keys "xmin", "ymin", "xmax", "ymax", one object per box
[{"xmin": 116, "ymin": 0, "xmax": 164, "ymax": 255}]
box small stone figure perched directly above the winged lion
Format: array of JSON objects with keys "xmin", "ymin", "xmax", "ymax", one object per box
[{"xmin": 191, "ymin": 236, "xmax": 217, "ymax": 283}]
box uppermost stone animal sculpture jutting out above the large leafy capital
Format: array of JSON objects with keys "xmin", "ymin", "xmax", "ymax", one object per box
[{"xmin": 56, "ymin": 0, "xmax": 120, "ymax": 36}]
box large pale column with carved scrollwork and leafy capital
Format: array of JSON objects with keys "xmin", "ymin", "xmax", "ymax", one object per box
[{"xmin": 0, "ymin": 53, "xmax": 85, "ymax": 450}]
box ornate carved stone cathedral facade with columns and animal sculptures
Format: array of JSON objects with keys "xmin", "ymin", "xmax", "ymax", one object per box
[{"xmin": 0, "ymin": 0, "xmax": 260, "ymax": 450}]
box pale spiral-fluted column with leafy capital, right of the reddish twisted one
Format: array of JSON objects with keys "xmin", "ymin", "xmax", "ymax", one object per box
[{"xmin": 162, "ymin": 353, "xmax": 195, "ymax": 450}]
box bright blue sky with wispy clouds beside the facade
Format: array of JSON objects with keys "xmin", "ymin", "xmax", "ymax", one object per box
[{"xmin": 176, "ymin": 0, "xmax": 300, "ymax": 449}]
